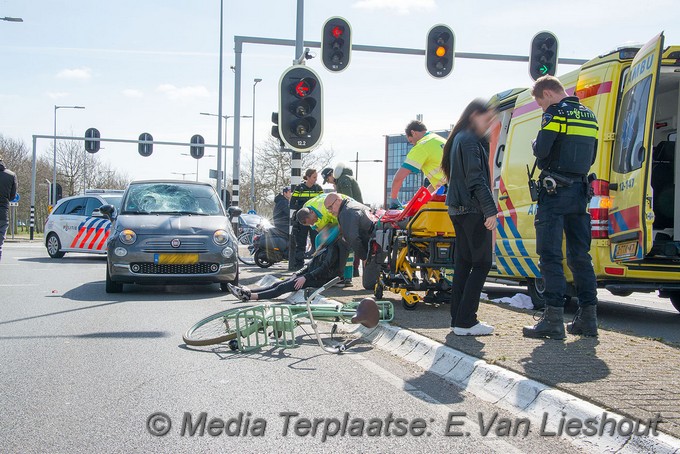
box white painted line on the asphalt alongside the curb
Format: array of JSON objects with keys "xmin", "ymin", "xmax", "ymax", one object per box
[{"xmin": 347, "ymin": 353, "xmax": 524, "ymax": 454}]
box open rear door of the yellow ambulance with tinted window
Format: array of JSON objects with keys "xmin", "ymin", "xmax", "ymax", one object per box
[{"xmin": 609, "ymin": 33, "xmax": 663, "ymax": 262}]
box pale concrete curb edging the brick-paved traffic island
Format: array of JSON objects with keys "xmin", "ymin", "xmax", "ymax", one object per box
[{"xmin": 350, "ymin": 324, "xmax": 680, "ymax": 454}]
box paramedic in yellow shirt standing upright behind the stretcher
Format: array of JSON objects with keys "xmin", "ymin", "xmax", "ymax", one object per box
[{"xmin": 389, "ymin": 120, "xmax": 446, "ymax": 207}]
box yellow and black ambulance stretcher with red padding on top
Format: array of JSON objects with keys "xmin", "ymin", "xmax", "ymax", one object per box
[{"xmin": 364, "ymin": 187, "xmax": 456, "ymax": 310}]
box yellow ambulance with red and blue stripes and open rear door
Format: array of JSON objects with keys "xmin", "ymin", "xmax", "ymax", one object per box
[{"xmin": 489, "ymin": 33, "xmax": 680, "ymax": 311}]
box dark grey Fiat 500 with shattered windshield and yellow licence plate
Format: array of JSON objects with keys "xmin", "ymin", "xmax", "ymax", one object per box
[{"xmin": 100, "ymin": 180, "xmax": 238, "ymax": 293}]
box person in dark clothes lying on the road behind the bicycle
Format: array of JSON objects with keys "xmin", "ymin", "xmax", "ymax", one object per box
[{"xmin": 227, "ymin": 226, "xmax": 340, "ymax": 302}]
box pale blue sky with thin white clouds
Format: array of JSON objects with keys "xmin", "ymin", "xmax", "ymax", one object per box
[{"xmin": 0, "ymin": 0, "xmax": 680, "ymax": 203}]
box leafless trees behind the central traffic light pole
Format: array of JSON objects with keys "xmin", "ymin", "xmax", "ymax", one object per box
[{"xmin": 239, "ymin": 137, "xmax": 335, "ymax": 217}]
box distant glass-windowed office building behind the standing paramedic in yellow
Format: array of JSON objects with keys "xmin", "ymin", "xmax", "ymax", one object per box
[{"xmin": 383, "ymin": 130, "xmax": 450, "ymax": 207}]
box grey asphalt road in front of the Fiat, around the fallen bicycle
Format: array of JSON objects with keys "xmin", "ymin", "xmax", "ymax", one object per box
[{"xmin": 0, "ymin": 243, "xmax": 677, "ymax": 453}]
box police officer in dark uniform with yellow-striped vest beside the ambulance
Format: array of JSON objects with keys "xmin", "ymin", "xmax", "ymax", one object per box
[{"xmin": 523, "ymin": 76, "xmax": 598, "ymax": 339}]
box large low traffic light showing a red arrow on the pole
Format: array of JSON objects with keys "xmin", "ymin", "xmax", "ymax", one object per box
[{"xmin": 278, "ymin": 65, "xmax": 323, "ymax": 152}]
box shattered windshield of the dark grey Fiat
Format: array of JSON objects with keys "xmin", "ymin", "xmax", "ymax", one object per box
[{"xmin": 121, "ymin": 183, "xmax": 224, "ymax": 216}]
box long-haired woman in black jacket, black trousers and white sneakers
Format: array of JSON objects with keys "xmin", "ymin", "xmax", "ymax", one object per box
[{"xmin": 441, "ymin": 99, "xmax": 497, "ymax": 336}]
